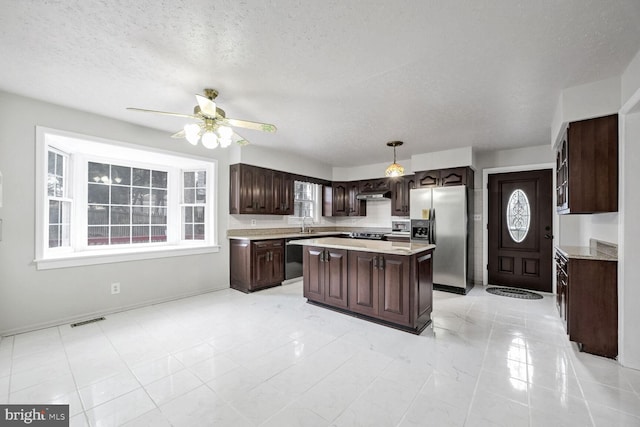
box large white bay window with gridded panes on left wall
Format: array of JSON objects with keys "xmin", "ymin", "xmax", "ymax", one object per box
[{"xmin": 36, "ymin": 127, "xmax": 217, "ymax": 268}]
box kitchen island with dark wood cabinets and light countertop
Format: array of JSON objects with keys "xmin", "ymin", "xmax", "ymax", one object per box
[{"xmin": 289, "ymin": 237, "xmax": 435, "ymax": 334}]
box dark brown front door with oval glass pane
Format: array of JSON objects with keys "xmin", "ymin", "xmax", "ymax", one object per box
[{"xmin": 488, "ymin": 169, "xmax": 553, "ymax": 292}]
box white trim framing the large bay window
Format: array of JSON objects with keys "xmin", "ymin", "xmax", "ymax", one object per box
[{"xmin": 34, "ymin": 126, "xmax": 220, "ymax": 270}]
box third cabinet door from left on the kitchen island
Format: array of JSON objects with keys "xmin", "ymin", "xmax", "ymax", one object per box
[{"xmin": 349, "ymin": 251, "xmax": 379, "ymax": 317}]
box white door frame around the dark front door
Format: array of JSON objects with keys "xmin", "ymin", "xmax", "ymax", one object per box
[{"xmin": 482, "ymin": 162, "xmax": 560, "ymax": 294}]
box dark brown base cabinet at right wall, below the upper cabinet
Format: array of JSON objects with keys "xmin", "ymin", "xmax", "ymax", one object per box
[{"xmin": 556, "ymin": 251, "xmax": 618, "ymax": 358}]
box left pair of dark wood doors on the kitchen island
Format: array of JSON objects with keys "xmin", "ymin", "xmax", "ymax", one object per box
[{"xmin": 302, "ymin": 246, "xmax": 348, "ymax": 308}]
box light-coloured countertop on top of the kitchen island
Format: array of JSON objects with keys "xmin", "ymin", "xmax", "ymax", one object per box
[{"xmin": 289, "ymin": 237, "xmax": 436, "ymax": 255}]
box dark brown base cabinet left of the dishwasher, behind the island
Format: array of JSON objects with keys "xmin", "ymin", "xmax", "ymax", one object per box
[{"xmin": 230, "ymin": 239, "xmax": 284, "ymax": 292}]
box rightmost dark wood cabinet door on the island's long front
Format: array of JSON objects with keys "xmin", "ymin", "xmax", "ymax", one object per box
[{"xmin": 378, "ymin": 255, "xmax": 410, "ymax": 326}]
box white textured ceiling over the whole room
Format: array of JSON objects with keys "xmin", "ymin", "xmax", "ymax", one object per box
[{"xmin": 0, "ymin": 0, "xmax": 640, "ymax": 166}]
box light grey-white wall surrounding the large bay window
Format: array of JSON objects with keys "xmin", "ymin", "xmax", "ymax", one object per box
[{"xmin": 0, "ymin": 92, "xmax": 229, "ymax": 334}]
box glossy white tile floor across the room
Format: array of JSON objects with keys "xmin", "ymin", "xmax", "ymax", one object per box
[{"xmin": 0, "ymin": 282, "xmax": 640, "ymax": 427}]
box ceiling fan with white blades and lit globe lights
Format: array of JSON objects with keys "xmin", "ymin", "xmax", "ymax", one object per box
[{"xmin": 127, "ymin": 89, "xmax": 276, "ymax": 149}]
